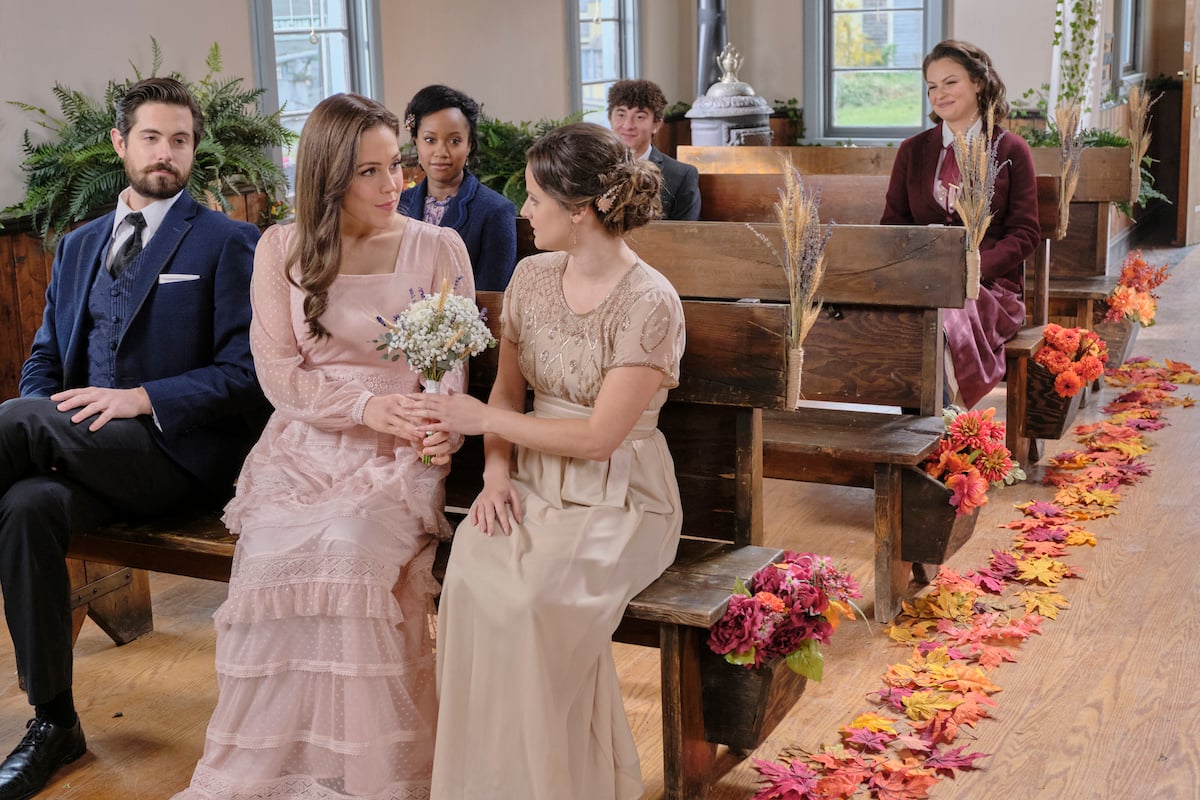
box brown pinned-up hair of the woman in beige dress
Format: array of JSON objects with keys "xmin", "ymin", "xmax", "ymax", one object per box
[{"xmin": 526, "ymin": 122, "xmax": 662, "ymax": 236}]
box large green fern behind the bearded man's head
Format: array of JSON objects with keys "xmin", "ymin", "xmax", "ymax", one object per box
[{"xmin": 5, "ymin": 37, "xmax": 295, "ymax": 246}]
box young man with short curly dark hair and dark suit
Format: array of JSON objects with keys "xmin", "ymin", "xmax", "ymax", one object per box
[{"xmin": 608, "ymin": 80, "xmax": 700, "ymax": 219}]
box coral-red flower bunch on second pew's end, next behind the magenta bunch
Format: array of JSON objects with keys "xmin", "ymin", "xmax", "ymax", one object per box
[{"xmin": 922, "ymin": 405, "xmax": 1025, "ymax": 517}]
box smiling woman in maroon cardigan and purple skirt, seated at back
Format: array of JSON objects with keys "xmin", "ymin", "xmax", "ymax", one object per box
[{"xmin": 880, "ymin": 40, "xmax": 1042, "ymax": 408}]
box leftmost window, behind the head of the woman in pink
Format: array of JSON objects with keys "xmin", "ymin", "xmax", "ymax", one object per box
[{"xmin": 252, "ymin": 0, "xmax": 383, "ymax": 193}]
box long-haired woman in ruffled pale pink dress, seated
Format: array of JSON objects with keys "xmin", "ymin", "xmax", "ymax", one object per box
[{"xmin": 178, "ymin": 95, "xmax": 474, "ymax": 800}]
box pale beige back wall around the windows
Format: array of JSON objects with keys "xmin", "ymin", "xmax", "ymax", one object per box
[{"xmin": 0, "ymin": 0, "xmax": 1182, "ymax": 206}]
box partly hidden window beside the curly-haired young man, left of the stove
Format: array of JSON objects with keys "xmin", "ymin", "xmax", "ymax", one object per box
[{"xmin": 566, "ymin": 0, "xmax": 638, "ymax": 122}]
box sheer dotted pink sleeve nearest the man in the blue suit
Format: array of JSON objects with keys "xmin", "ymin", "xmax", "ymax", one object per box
[{"xmin": 250, "ymin": 225, "xmax": 372, "ymax": 431}]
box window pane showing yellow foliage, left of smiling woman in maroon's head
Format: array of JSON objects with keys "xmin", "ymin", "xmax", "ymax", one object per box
[{"xmin": 833, "ymin": 11, "xmax": 924, "ymax": 68}]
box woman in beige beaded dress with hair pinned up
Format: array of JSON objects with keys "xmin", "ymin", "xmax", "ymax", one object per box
[{"xmin": 416, "ymin": 122, "xmax": 684, "ymax": 800}]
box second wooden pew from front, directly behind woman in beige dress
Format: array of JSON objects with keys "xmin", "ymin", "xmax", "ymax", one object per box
[{"xmin": 629, "ymin": 221, "xmax": 968, "ymax": 621}]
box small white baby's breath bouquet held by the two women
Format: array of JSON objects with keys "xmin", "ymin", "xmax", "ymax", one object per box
[{"xmin": 372, "ymin": 275, "xmax": 496, "ymax": 464}]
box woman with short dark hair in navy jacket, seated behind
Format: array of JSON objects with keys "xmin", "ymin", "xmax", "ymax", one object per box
[{"xmin": 398, "ymin": 85, "xmax": 517, "ymax": 291}]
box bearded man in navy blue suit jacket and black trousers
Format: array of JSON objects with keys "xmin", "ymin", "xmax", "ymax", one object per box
[{"xmin": 0, "ymin": 78, "xmax": 266, "ymax": 800}]
